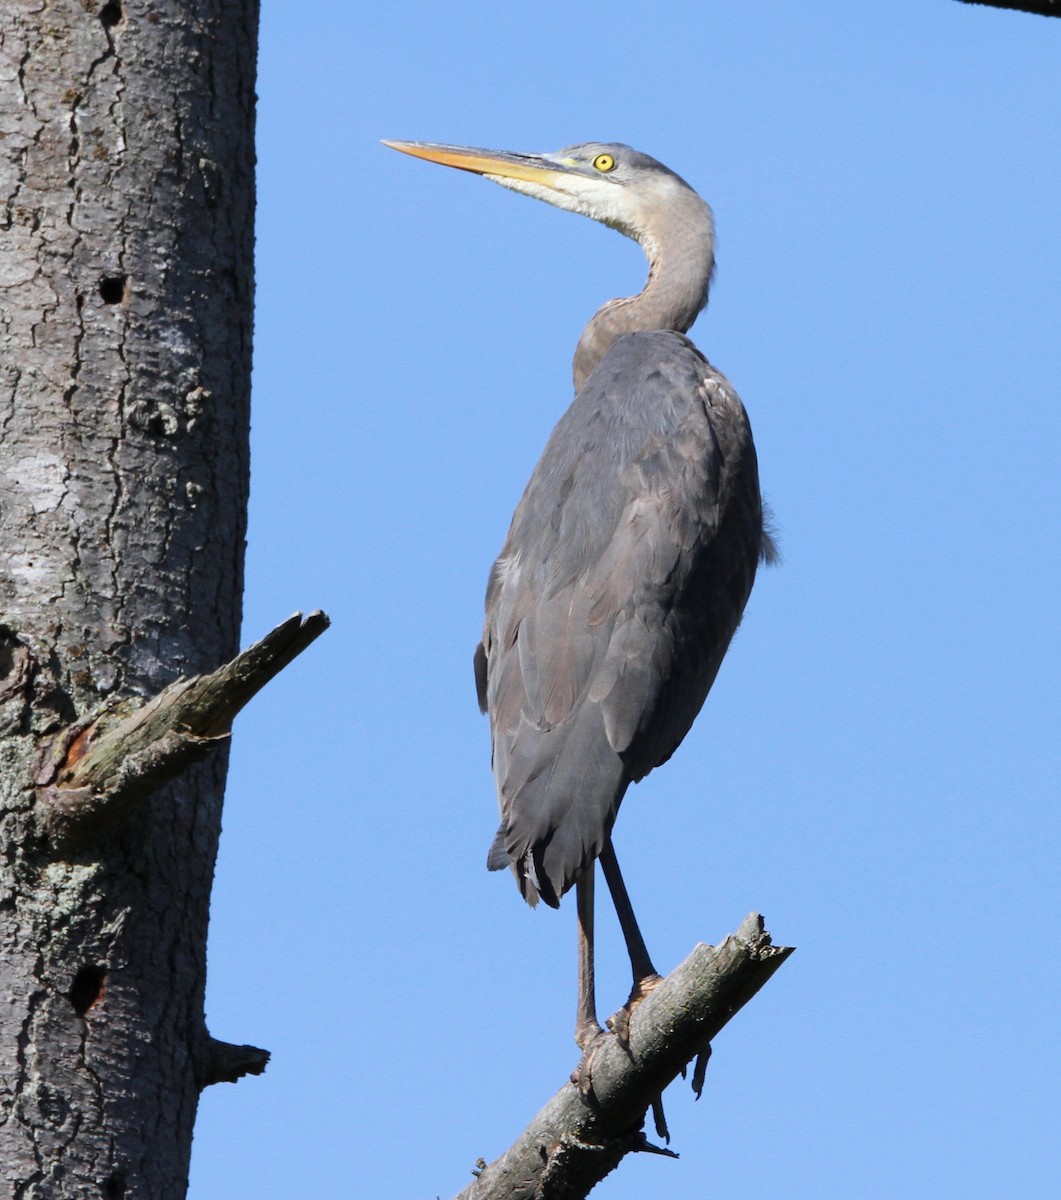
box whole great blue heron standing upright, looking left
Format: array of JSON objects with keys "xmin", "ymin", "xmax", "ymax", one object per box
[{"xmin": 386, "ymin": 142, "xmax": 774, "ymax": 1050}]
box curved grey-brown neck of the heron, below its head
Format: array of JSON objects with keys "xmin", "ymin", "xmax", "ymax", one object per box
[{"xmin": 574, "ymin": 192, "xmax": 714, "ymax": 392}]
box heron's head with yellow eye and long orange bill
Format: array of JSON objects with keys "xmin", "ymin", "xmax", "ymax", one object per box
[{"xmin": 384, "ymin": 142, "xmax": 712, "ymax": 257}]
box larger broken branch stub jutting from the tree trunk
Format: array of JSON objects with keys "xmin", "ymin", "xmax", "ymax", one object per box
[{"xmin": 36, "ymin": 612, "xmax": 329, "ymax": 835}]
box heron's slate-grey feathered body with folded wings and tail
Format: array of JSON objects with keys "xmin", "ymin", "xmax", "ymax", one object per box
[{"xmin": 475, "ymin": 331, "xmax": 762, "ymax": 905}]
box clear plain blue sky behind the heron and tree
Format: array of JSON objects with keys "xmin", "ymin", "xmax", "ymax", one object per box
[{"xmin": 191, "ymin": 0, "xmax": 1061, "ymax": 1200}]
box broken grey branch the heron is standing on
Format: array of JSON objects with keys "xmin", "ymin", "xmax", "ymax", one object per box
[{"xmin": 456, "ymin": 913, "xmax": 792, "ymax": 1200}]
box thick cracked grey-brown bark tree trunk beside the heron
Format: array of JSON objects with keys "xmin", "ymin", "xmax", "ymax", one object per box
[{"xmin": 0, "ymin": 0, "xmax": 260, "ymax": 1200}]
